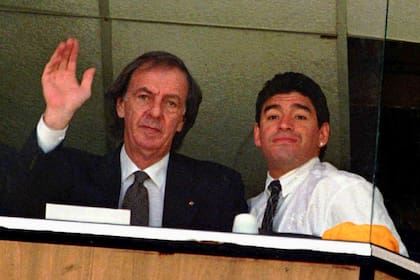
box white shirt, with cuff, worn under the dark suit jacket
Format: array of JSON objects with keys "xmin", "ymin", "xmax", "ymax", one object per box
[{"xmin": 37, "ymin": 117, "xmax": 169, "ymax": 227}]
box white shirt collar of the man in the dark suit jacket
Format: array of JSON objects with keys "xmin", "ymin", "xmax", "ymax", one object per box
[{"xmin": 120, "ymin": 145, "xmax": 169, "ymax": 187}]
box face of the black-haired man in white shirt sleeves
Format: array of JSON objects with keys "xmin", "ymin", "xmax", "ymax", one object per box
[{"xmin": 254, "ymin": 92, "xmax": 330, "ymax": 178}]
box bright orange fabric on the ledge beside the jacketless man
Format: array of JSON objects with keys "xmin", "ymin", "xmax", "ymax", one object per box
[{"xmin": 322, "ymin": 222, "xmax": 399, "ymax": 253}]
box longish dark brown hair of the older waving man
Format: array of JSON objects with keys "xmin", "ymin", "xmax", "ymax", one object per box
[{"xmin": 105, "ymin": 51, "xmax": 202, "ymax": 150}]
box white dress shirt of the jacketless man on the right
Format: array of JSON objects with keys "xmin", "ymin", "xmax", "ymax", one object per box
[{"xmin": 248, "ymin": 158, "xmax": 408, "ymax": 255}]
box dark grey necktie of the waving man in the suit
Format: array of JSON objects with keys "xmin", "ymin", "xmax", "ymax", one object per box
[{"xmin": 122, "ymin": 171, "xmax": 149, "ymax": 226}]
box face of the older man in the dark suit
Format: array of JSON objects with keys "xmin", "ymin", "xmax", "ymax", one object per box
[{"xmin": 117, "ymin": 67, "xmax": 188, "ymax": 161}]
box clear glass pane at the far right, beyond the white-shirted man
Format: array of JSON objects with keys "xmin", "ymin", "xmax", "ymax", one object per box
[{"xmin": 375, "ymin": 1, "xmax": 420, "ymax": 261}]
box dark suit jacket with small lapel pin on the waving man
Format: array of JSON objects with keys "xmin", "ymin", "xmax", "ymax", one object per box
[{"xmin": 22, "ymin": 132, "xmax": 248, "ymax": 231}]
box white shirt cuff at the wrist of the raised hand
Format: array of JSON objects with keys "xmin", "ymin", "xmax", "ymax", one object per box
[{"xmin": 36, "ymin": 116, "xmax": 68, "ymax": 153}]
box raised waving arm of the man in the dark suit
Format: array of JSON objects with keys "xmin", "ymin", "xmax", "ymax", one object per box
[{"xmin": 14, "ymin": 38, "xmax": 95, "ymax": 218}]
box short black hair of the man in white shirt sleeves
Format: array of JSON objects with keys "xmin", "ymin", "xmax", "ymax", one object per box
[{"xmin": 255, "ymin": 72, "xmax": 330, "ymax": 127}]
